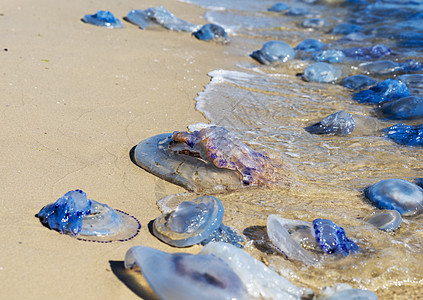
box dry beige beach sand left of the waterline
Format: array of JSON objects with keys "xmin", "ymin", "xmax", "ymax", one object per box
[{"xmin": 0, "ymin": 0, "xmax": 238, "ymax": 299}]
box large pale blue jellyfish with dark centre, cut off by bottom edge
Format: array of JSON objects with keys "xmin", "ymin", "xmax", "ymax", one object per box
[{"xmin": 125, "ymin": 246, "xmax": 250, "ymax": 300}]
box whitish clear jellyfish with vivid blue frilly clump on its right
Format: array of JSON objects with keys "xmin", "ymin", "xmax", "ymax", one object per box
[{"xmin": 267, "ymin": 215, "xmax": 359, "ymax": 265}]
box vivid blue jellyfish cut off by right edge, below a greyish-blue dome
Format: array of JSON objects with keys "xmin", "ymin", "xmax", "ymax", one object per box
[{"xmin": 383, "ymin": 123, "xmax": 423, "ymax": 146}]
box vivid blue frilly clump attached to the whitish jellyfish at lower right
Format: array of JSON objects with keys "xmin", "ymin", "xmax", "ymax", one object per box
[{"xmin": 313, "ymin": 219, "xmax": 359, "ymax": 256}]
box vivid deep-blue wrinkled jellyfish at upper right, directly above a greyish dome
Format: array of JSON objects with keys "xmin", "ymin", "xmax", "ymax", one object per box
[{"xmin": 353, "ymin": 79, "xmax": 410, "ymax": 103}]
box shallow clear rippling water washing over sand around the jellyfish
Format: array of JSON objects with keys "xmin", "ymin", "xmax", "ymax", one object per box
[{"xmin": 176, "ymin": 0, "xmax": 423, "ymax": 299}]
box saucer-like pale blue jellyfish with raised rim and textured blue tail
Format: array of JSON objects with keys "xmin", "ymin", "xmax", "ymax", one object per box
[{"xmin": 153, "ymin": 196, "xmax": 243, "ymax": 247}]
